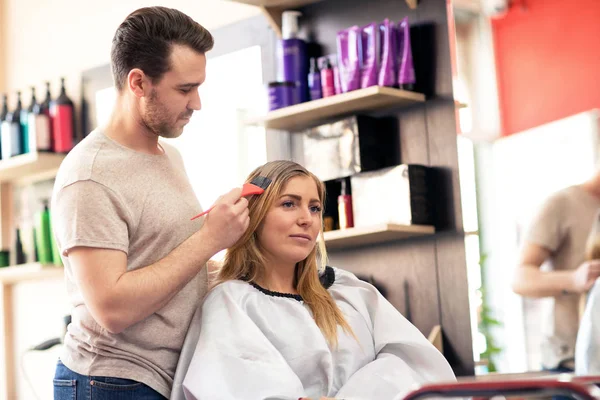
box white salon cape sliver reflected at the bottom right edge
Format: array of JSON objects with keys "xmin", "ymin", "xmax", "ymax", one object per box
[{"xmin": 575, "ymin": 279, "xmax": 600, "ymax": 375}]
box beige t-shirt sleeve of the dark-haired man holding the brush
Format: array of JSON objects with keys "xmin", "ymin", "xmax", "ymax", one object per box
[{"xmin": 52, "ymin": 180, "xmax": 132, "ymax": 257}]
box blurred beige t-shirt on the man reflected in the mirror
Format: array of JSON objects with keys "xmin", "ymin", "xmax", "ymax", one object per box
[{"xmin": 525, "ymin": 186, "xmax": 600, "ymax": 368}]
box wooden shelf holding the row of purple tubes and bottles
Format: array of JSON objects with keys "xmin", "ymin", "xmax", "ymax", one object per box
[{"xmin": 247, "ymin": 86, "xmax": 425, "ymax": 130}]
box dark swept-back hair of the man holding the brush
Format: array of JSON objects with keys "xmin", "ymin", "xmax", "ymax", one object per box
[{"xmin": 110, "ymin": 7, "xmax": 214, "ymax": 91}]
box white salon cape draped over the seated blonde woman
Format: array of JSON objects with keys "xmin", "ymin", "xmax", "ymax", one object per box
[{"xmin": 172, "ymin": 267, "xmax": 456, "ymax": 400}]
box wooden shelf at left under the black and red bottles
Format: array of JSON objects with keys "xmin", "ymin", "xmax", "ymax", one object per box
[{"xmin": 0, "ymin": 153, "xmax": 65, "ymax": 183}]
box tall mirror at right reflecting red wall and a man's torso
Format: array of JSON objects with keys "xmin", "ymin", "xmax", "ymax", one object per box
[{"xmin": 451, "ymin": 0, "xmax": 600, "ymax": 375}]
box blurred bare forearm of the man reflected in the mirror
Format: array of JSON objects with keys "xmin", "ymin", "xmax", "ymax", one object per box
[{"xmin": 512, "ymin": 265, "xmax": 575, "ymax": 297}]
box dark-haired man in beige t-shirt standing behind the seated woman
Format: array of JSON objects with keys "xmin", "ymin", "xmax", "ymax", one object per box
[{"xmin": 52, "ymin": 7, "xmax": 249, "ymax": 400}]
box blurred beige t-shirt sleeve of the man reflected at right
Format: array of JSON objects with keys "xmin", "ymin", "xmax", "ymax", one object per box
[{"xmin": 525, "ymin": 193, "xmax": 565, "ymax": 252}]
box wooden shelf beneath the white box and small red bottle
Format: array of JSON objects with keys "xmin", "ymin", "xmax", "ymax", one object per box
[{"xmin": 324, "ymin": 224, "xmax": 435, "ymax": 250}]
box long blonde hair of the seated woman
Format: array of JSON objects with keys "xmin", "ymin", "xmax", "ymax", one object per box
[{"xmin": 215, "ymin": 161, "xmax": 354, "ymax": 346}]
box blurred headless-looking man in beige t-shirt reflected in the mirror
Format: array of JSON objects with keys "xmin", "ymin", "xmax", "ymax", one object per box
[{"xmin": 513, "ymin": 175, "xmax": 600, "ymax": 372}]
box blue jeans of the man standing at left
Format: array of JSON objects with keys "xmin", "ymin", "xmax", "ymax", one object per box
[{"xmin": 54, "ymin": 360, "xmax": 166, "ymax": 400}]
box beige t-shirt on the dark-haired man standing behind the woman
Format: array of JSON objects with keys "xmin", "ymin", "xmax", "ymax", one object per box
[{"xmin": 52, "ymin": 130, "xmax": 207, "ymax": 397}]
